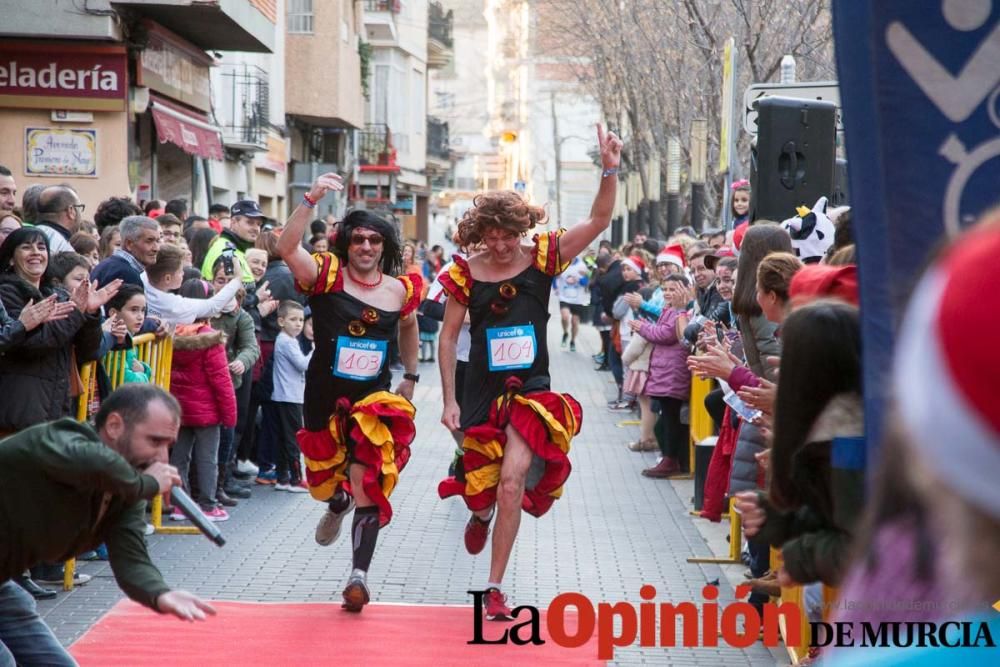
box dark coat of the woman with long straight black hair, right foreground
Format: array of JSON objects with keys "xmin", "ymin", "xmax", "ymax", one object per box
[{"xmin": 758, "ymin": 394, "xmax": 864, "ymax": 586}]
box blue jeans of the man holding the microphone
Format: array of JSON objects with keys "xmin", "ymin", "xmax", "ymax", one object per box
[{"xmin": 0, "ymin": 581, "xmax": 77, "ymax": 667}]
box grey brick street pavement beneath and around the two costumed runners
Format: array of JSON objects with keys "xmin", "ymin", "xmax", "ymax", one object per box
[{"xmin": 39, "ymin": 306, "xmax": 780, "ymax": 665}]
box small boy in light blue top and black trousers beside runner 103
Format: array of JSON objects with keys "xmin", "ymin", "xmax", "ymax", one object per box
[{"xmin": 270, "ymin": 300, "xmax": 312, "ymax": 493}]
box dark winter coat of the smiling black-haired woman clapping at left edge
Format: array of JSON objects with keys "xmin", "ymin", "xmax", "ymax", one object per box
[{"xmin": 0, "ymin": 273, "xmax": 101, "ymax": 431}]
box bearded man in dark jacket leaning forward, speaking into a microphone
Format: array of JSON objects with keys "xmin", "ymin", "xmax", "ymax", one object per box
[{"xmin": 0, "ymin": 384, "xmax": 215, "ymax": 665}]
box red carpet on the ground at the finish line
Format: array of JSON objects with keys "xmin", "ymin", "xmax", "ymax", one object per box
[{"xmin": 70, "ymin": 600, "xmax": 599, "ymax": 667}]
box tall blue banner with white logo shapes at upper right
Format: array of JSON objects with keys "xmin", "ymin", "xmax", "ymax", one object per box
[{"xmin": 833, "ymin": 0, "xmax": 1000, "ymax": 454}]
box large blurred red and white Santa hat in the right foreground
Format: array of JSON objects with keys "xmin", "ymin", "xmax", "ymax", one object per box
[{"xmin": 893, "ymin": 225, "xmax": 1000, "ymax": 519}]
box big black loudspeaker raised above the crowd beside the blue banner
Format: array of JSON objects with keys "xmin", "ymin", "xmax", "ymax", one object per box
[{"xmin": 750, "ymin": 97, "xmax": 837, "ymax": 222}]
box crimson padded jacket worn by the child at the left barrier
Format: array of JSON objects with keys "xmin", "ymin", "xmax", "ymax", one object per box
[{"xmin": 170, "ymin": 322, "xmax": 236, "ymax": 428}]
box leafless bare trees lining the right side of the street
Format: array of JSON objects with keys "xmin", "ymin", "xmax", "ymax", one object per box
[{"xmin": 533, "ymin": 0, "xmax": 834, "ymax": 228}]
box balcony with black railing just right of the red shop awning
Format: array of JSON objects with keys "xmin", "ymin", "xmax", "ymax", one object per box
[{"xmin": 215, "ymin": 63, "xmax": 271, "ymax": 152}]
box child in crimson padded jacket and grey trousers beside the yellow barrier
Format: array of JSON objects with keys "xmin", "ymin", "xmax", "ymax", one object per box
[{"xmin": 170, "ymin": 276, "xmax": 236, "ymax": 521}]
